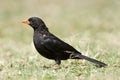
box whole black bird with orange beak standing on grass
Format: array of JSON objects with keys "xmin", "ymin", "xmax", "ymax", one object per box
[{"xmin": 22, "ymin": 17, "xmax": 107, "ymax": 67}]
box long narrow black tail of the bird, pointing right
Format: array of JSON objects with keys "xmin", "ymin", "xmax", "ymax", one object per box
[{"xmin": 71, "ymin": 55, "xmax": 107, "ymax": 67}]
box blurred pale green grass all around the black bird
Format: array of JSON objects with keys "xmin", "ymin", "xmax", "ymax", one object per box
[{"xmin": 0, "ymin": 0, "xmax": 120, "ymax": 80}]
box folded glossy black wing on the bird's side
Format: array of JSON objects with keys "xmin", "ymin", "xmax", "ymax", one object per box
[{"xmin": 44, "ymin": 34, "xmax": 77, "ymax": 53}]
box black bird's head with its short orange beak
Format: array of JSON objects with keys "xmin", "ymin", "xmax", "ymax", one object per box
[{"xmin": 23, "ymin": 17, "xmax": 46, "ymax": 29}]
